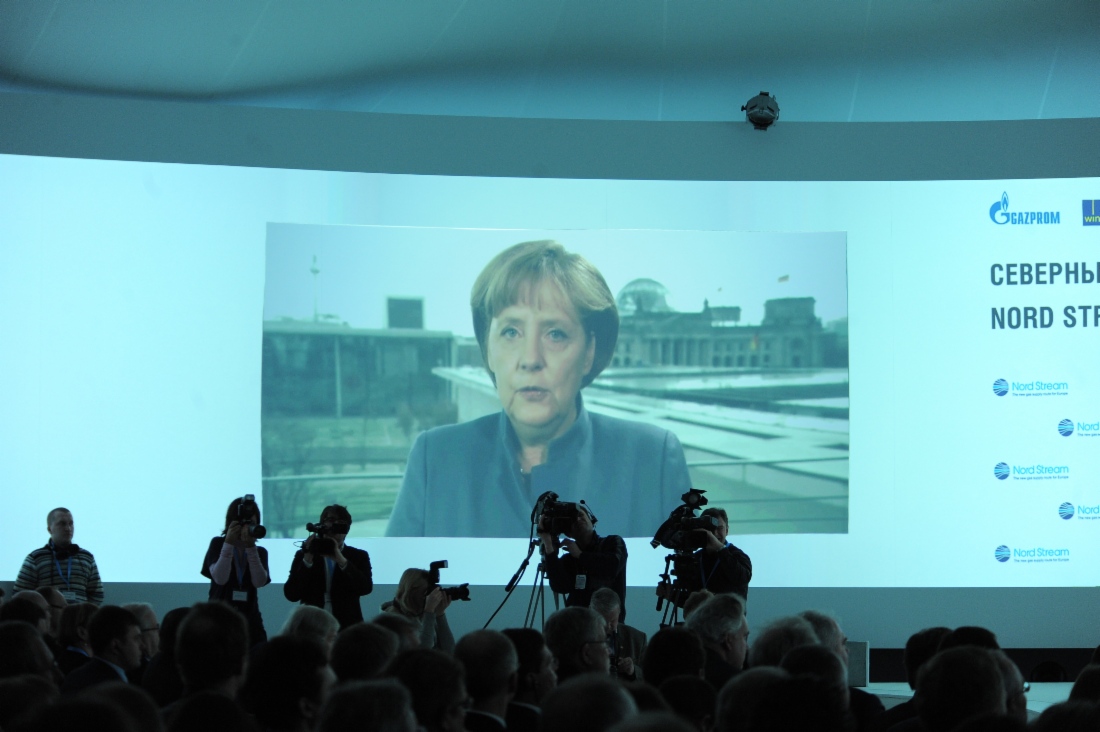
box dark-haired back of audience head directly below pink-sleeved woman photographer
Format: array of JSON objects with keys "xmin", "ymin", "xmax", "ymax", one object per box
[{"xmin": 176, "ymin": 602, "xmax": 249, "ymax": 692}]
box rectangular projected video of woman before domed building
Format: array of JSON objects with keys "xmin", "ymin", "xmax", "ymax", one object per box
[{"xmin": 261, "ymin": 223, "xmax": 848, "ymax": 537}]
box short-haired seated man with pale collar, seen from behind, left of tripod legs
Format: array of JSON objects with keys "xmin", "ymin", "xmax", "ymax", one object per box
[{"xmin": 454, "ymin": 630, "xmax": 519, "ymax": 732}]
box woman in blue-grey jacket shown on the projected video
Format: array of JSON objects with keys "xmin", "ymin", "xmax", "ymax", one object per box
[{"xmin": 386, "ymin": 241, "xmax": 691, "ymax": 537}]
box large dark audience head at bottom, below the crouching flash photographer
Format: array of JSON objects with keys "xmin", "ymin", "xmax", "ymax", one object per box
[{"xmin": 389, "ymin": 648, "xmax": 470, "ymax": 732}]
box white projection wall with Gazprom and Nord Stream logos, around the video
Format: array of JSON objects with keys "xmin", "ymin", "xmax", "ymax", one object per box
[{"xmin": 0, "ymin": 150, "xmax": 1100, "ymax": 587}]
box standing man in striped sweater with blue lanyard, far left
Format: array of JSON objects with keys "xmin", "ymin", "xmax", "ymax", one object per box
[{"xmin": 14, "ymin": 509, "xmax": 103, "ymax": 605}]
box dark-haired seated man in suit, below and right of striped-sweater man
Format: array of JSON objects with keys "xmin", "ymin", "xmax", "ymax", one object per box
[{"xmin": 62, "ymin": 605, "xmax": 141, "ymax": 696}]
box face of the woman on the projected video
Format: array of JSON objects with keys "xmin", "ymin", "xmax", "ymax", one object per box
[{"xmin": 487, "ymin": 280, "xmax": 596, "ymax": 440}]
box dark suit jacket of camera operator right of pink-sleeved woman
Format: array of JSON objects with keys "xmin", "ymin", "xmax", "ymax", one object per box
[{"xmin": 283, "ymin": 545, "xmax": 374, "ymax": 629}]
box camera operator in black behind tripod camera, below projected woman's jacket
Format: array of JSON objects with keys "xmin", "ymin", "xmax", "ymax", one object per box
[{"xmin": 538, "ymin": 503, "xmax": 626, "ymax": 621}]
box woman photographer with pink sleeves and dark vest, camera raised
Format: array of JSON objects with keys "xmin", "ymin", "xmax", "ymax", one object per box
[{"xmin": 201, "ymin": 495, "xmax": 272, "ymax": 646}]
